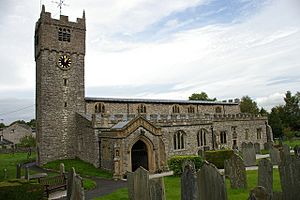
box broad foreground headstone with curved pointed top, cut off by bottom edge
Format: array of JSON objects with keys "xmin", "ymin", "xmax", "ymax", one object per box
[{"xmin": 197, "ymin": 162, "xmax": 227, "ymax": 200}]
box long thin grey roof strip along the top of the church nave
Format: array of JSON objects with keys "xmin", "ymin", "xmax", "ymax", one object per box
[{"xmin": 85, "ymin": 97, "xmax": 238, "ymax": 105}]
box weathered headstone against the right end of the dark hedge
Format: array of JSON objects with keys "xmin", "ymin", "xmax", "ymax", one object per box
[{"xmin": 224, "ymin": 154, "xmax": 247, "ymax": 189}]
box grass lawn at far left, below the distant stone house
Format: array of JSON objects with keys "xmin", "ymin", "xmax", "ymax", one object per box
[{"xmin": 0, "ymin": 153, "xmax": 36, "ymax": 181}]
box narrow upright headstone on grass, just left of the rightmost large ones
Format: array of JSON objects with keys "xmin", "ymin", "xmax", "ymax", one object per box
[{"xmin": 257, "ymin": 158, "xmax": 273, "ymax": 196}]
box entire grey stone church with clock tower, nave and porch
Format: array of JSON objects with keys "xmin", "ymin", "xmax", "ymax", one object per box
[{"xmin": 35, "ymin": 6, "xmax": 272, "ymax": 178}]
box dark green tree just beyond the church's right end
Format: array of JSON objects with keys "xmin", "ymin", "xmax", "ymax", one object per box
[{"xmin": 268, "ymin": 106, "xmax": 283, "ymax": 138}]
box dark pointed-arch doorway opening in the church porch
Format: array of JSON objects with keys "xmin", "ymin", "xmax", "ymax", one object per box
[{"xmin": 131, "ymin": 140, "xmax": 149, "ymax": 172}]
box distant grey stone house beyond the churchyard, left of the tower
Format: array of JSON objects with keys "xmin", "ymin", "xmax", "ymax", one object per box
[{"xmin": 0, "ymin": 123, "xmax": 33, "ymax": 144}]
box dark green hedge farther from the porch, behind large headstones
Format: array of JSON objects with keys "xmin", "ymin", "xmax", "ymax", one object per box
[{"xmin": 205, "ymin": 150, "xmax": 233, "ymax": 169}]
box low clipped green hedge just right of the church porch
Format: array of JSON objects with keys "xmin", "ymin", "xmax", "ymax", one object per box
[{"xmin": 168, "ymin": 156, "xmax": 203, "ymax": 176}]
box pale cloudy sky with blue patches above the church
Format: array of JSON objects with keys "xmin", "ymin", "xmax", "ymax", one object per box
[{"xmin": 0, "ymin": 0, "xmax": 300, "ymax": 124}]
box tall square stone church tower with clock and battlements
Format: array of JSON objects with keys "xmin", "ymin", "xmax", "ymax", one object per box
[{"xmin": 35, "ymin": 5, "xmax": 86, "ymax": 165}]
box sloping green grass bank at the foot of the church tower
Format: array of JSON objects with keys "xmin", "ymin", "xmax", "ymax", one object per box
[{"xmin": 44, "ymin": 158, "xmax": 112, "ymax": 178}]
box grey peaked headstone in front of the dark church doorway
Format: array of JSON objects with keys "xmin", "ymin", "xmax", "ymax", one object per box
[{"xmin": 127, "ymin": 167, "xmax": 150, "ymax": 200}]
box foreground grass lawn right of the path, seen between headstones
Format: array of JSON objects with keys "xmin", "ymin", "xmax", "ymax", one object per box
[{"xmin": 96, "ymin": 169, "xmax": 281, "ymax": 200}]
